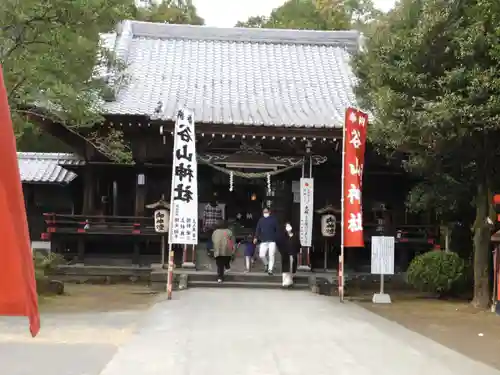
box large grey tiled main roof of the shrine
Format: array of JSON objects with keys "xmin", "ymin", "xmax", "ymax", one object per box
[{"xmin": 104, "ymin": 21, "xmax": 360, "ymax": 127}]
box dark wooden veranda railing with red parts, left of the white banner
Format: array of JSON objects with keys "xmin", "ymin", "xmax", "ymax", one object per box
[{"xmin": 42, "ymin": 213, "xmax": 157, "ymax": 239}]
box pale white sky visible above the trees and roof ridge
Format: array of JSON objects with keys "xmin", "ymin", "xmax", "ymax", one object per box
[{"xmin": 193, "ymin": 0, "xmax": 395, "ymax": 27}]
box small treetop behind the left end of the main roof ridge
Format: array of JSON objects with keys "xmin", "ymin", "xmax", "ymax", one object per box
[{"xmin": 135, "ymin": 0, "xmax": 205, "ymax": 25}]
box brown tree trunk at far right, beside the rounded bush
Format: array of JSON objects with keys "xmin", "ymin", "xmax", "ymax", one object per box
[{"xmin": 472, "ymin": 185, "xmax": 490, "ymax": 309}]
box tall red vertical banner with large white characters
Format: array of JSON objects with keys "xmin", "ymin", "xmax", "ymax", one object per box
[{"xmin": 342, "ymin": 108, "xmax": 368, "ymax": 247}]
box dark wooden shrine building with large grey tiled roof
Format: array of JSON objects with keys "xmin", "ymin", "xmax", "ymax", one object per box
[{"xmin": 33, "ymin": 21, "xmax": 436, "ymax": 269}]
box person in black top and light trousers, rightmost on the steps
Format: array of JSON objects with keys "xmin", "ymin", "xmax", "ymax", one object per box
[{"xmin": 278, "ymin": 222, "xmax": 300, "ymax": 288}]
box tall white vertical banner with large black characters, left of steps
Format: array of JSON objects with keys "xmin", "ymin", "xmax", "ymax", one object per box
[{"xmin": 168, "ymin": 109, "xmax": 198, "ymax": 245}]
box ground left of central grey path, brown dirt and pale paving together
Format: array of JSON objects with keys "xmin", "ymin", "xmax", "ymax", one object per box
[{"xmin": 0, "ymin": 284, "xmax": 160, "ymax": 375}]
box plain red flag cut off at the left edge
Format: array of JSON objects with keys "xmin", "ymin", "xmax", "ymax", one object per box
[{"xmin": 0, "ymin": 66, "xmax": 40, "ymax": 337}]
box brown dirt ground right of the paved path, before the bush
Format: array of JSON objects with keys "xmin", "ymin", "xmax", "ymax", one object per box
[{"xmin": 353, "ymin": 293, "xmax": 500, "ymax": 369}]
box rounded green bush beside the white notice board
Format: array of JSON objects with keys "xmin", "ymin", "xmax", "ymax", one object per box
[{"xmin": 406, "ymin": 251, "xmax": 465, "ymax": 295}]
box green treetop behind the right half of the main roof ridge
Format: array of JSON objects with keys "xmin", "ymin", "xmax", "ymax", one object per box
[{"xmin": 236, "ymin": 0, "xmax": 380, "ymax": 30}]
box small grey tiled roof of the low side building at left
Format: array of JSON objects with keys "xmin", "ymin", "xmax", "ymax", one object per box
[{"xmin": 17, "ymin": 152, "xmax": 84, "ymax": 184}]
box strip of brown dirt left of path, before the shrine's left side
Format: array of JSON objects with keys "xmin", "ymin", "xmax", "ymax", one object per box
[{"xmin": 40, "ymin": 284, "xmax": 157, "ymax": 313}]
